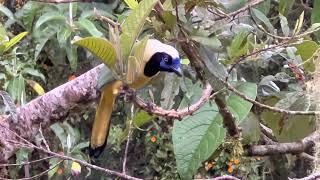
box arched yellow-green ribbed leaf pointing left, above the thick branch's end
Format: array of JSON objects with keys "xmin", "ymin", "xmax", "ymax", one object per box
[{"xmin": 73, "ymin": 37, "xmax": 116, "ymax": 68}]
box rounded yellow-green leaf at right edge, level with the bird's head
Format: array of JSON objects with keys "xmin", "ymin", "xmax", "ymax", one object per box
[{"xmin": 295, "ymin": 40, "xmax": 319, "ymax": 72}]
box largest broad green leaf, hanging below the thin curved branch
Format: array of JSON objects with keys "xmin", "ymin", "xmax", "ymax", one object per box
[{"xmin": 172, "ymin": 104, "xmax": 222, "ymax": 179}]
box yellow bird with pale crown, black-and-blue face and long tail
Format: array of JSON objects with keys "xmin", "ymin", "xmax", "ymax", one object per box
[{"xmin": 89, "ymin": 39, "xmax": 182, "ymax": 158}]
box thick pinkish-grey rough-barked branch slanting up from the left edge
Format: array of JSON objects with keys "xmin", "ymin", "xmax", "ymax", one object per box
[{"xmin": 0, "ymin": 65, "xmax": 103, "ymax": 162}]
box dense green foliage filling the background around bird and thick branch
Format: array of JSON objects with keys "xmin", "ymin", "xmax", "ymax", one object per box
[{"xmin": 0, "ymin": 0, "xmax": 320, "ymax": 179}]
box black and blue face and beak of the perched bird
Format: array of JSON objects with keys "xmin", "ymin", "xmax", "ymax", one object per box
[{"xmin": 144, "ymin": 52, "xmax": 182, "ymax": 77}]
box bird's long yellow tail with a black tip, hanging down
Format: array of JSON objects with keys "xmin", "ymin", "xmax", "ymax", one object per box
[{"xmin": 89, "ymin": 81, "xmax": 122, "ymax": 157}]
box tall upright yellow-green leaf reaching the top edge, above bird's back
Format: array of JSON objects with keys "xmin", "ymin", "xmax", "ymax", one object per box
[{"xmin": 120, "ymin": 0, "xmax": 158, "ymax": 60}]
